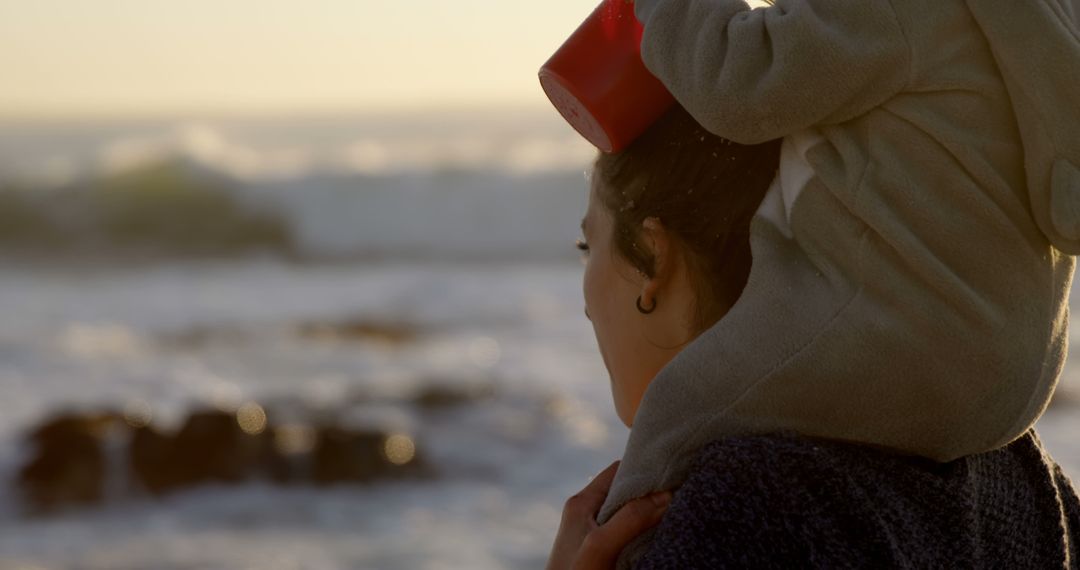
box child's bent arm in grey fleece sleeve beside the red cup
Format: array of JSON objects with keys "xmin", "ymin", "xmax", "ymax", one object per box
[{"xmin": 634, "ymin": 0, "xmax": 912, "ymax": 144}]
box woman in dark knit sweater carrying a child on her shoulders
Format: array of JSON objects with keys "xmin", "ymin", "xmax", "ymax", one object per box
[{"xmin": 549, "ymin": 105, "xmax": 1080, "ymax": 569}]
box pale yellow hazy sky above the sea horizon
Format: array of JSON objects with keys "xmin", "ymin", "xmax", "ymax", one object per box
[{"xmin": 0, "ymin": 0, "xmax": 599, "ymax": 118}]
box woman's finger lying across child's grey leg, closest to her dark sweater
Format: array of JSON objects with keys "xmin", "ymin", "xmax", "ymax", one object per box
[{"xmin": 573, "ymin": 491, "xmax": 672, "ymax": 569}]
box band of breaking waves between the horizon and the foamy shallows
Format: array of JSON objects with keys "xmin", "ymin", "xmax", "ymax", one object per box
[{"xmin": 0, "ymin": 111, "xmax": 596, "ymax": 259}]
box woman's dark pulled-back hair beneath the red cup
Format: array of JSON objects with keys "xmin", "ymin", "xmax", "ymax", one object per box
[{"xmin": 593, "ymin": 103, "xmax": 781, "ymax": 333}]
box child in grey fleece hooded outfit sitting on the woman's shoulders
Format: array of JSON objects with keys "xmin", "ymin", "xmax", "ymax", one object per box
[{"xmin": 598, "ymin": 0, "xmax": 1080, "ymax": 565}]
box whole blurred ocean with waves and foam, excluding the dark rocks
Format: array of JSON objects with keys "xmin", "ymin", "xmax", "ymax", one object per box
[{"xmin": 0, "ymin": 110, "xmax": 1080, "ymax": 570}]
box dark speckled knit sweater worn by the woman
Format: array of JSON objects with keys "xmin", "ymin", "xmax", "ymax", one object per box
[{"xmin": 635, "ymin": 431, "xmax": 1080, "ymax": 570}]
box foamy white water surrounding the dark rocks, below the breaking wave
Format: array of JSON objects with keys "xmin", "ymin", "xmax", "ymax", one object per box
[{"xmin": 0, "ymin": 259, "xmax": 625, "ymax": 569}]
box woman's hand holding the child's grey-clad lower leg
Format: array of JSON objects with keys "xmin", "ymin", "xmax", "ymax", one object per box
[{"xmin": 548, "ymin": 461, "xmax": 672, "ymax": 570}]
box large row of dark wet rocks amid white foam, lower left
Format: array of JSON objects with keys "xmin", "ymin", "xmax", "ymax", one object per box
[{"xmin": 17, "ymin": 399, "xmax": 442, "ymax": 512}]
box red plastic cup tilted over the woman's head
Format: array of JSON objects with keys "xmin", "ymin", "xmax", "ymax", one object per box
[{"xmin": 540, "ymin": 0, "xmax": 675, "ymax": 152}]
